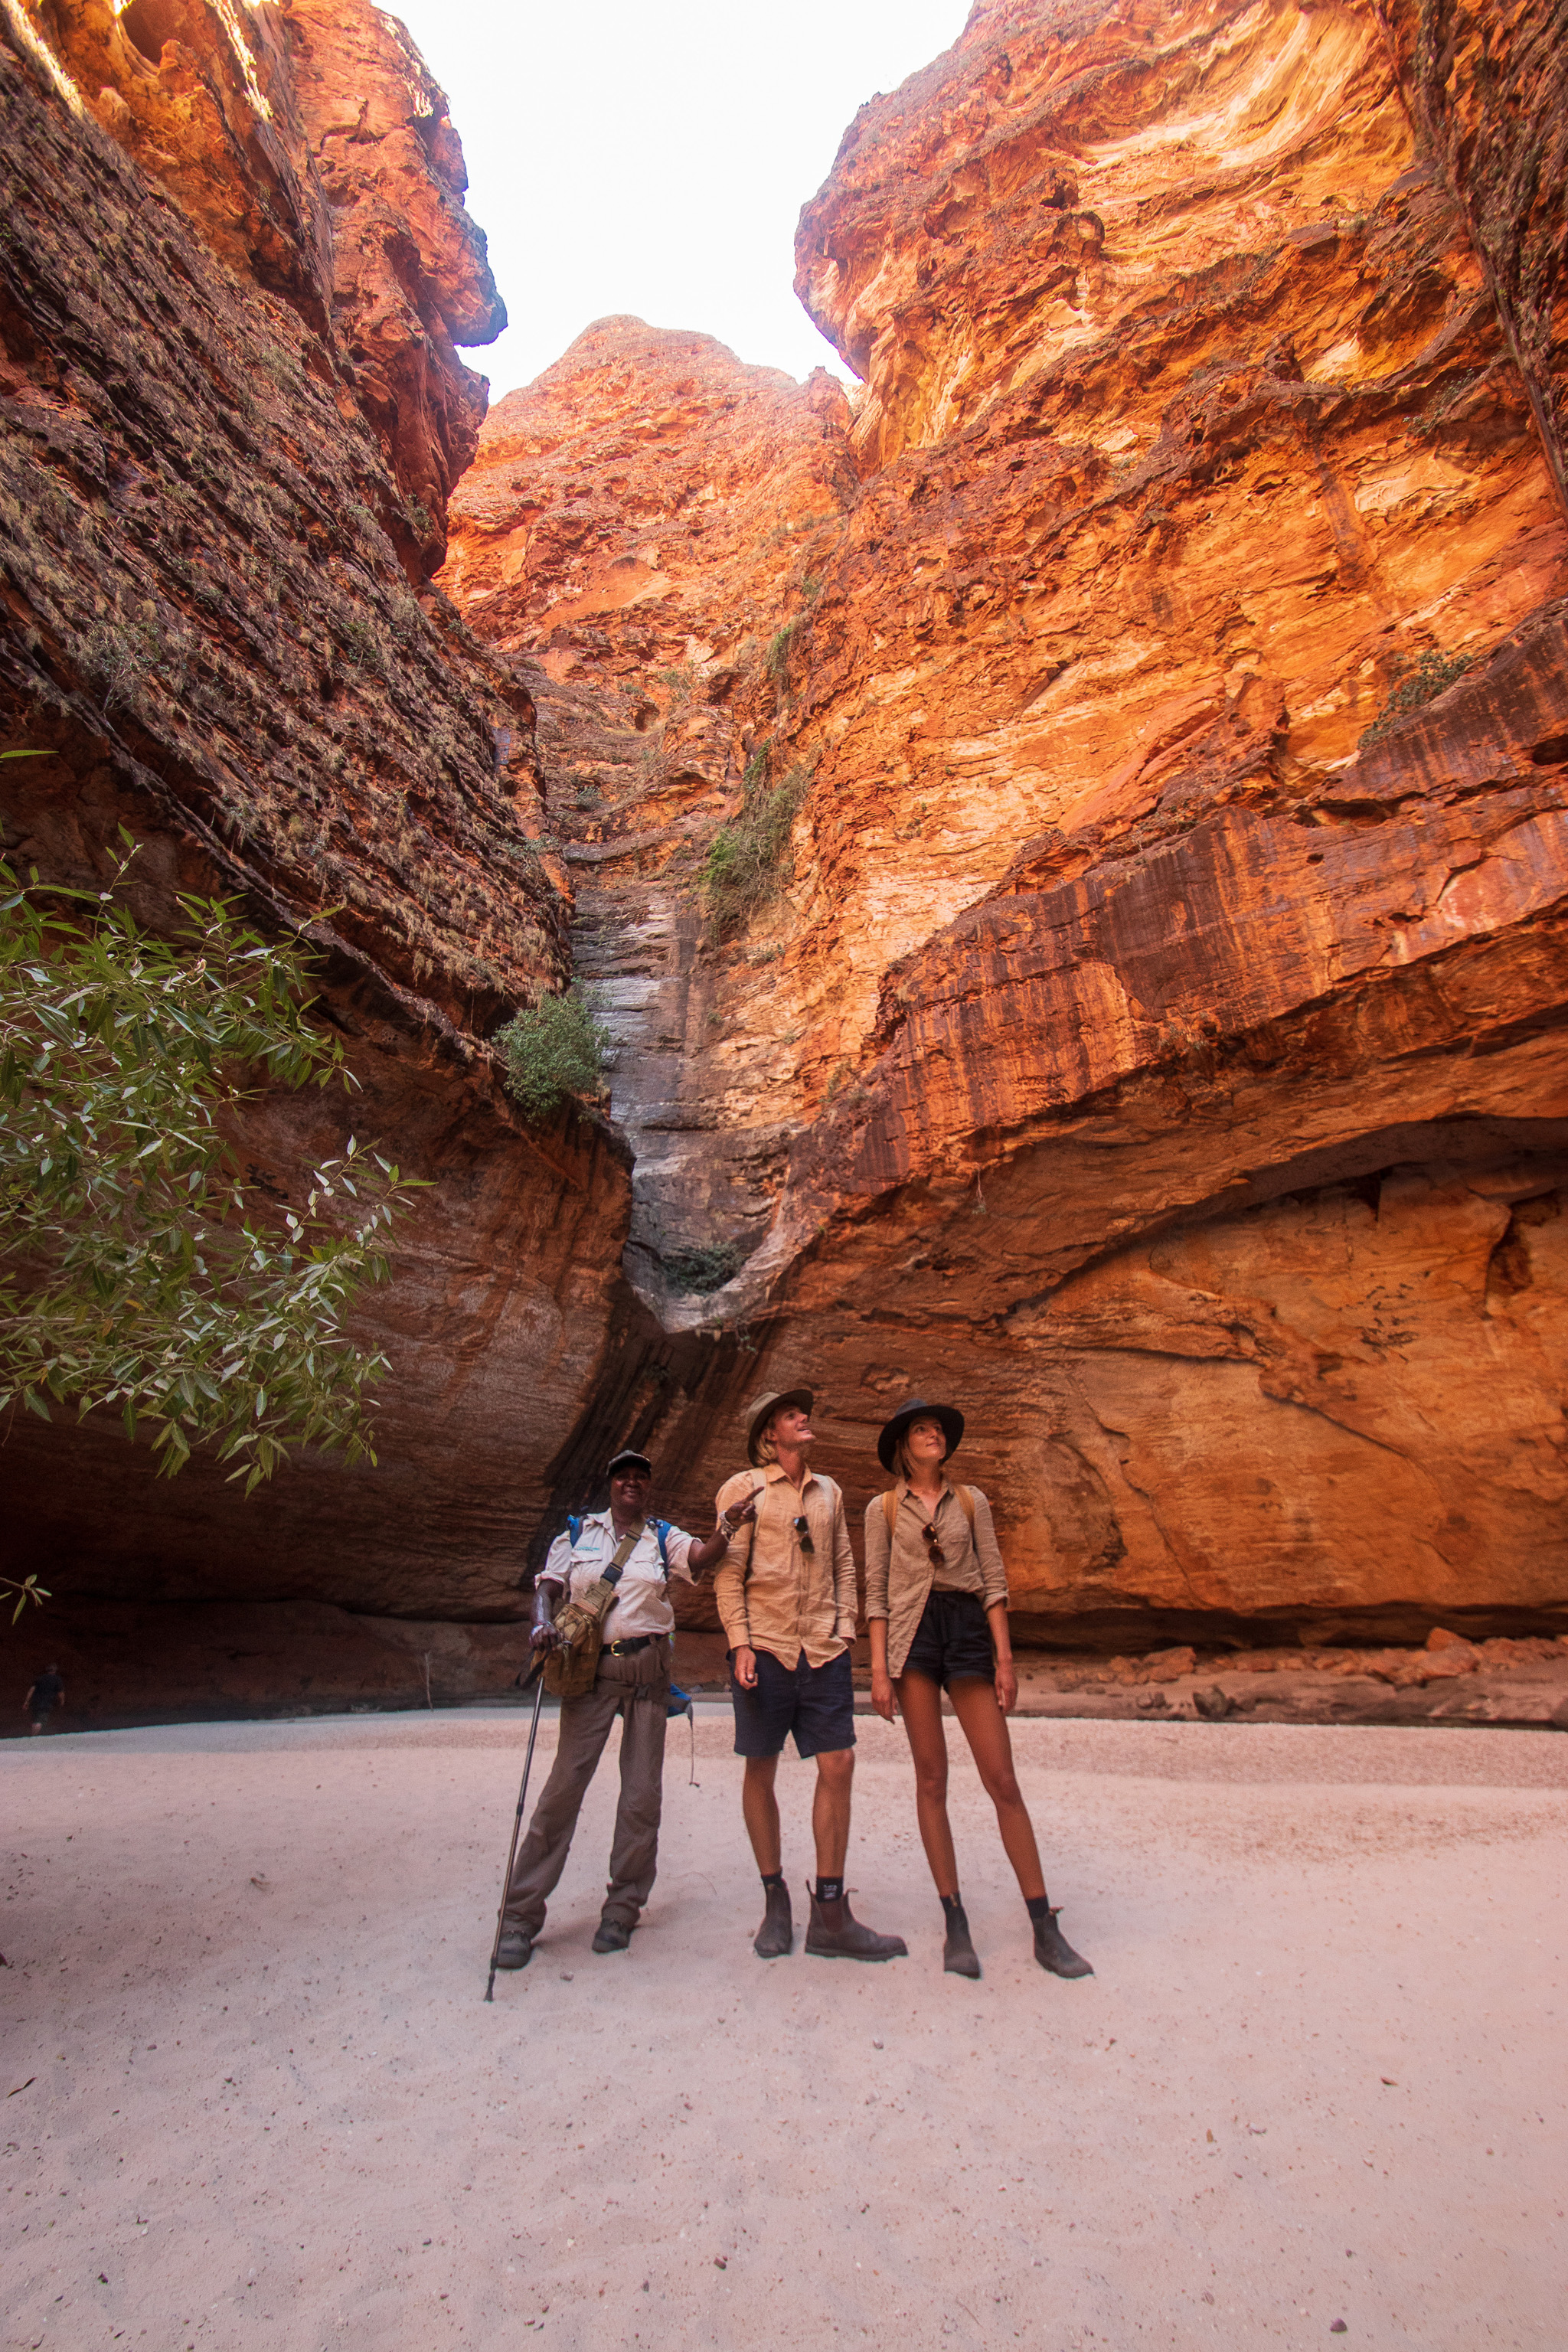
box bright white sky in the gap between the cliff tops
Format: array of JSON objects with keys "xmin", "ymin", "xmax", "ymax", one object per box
[{"xmin": 383, "ymin": 0, "xmax": 969, "ymax": 397}]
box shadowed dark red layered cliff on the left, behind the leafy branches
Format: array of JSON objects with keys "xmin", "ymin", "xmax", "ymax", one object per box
[{"xmin": 0, "ymin": 0, "xmax": 628, "ymax": 1615}]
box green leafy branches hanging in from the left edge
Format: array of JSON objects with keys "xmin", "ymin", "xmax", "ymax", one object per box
[{"xmin": 0, "ymin": 838, "xmax": 423, "ymax": 1494}]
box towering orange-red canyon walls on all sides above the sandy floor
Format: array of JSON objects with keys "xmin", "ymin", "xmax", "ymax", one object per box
[{"xmin": 0, "ymin": 0, "xmax": 1568, "ymax": 1712}]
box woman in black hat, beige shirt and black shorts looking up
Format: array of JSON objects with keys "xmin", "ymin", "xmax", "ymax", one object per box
[{"xmin": 865, "ymin": 1397, "xmax": 1093, "ymax": 1975}]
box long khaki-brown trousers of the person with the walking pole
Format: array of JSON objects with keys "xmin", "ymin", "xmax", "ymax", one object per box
[{"xmin": 505, "ymin": 1642, "xmax": 670, "ymax": 1936}]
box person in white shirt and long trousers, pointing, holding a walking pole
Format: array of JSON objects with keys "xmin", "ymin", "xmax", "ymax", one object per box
[{"xmin": 496, "ymin": 1449, "xmax": 752, "ymax": 1968}]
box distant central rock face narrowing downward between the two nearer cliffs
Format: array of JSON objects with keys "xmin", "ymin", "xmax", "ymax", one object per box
[{"xmin": 442, "ymin": 318, "xmax": 858, "ymax": 1327}]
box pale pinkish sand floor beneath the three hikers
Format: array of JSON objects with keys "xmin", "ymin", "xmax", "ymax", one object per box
[{"xmin": 0, "ymin": 1714, "xmax": 1568, "ymax": 2352}]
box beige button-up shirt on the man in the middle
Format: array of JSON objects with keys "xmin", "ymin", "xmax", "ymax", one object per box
[{"xmin": 712, "ymin": 1463, "xmax": 858, "ymax": 1665}]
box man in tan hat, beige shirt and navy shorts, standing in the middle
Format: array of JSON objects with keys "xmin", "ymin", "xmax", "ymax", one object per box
[{"xmin": 712, "ymin": 1387, "xmax": 907, "ymax": 1959}]
